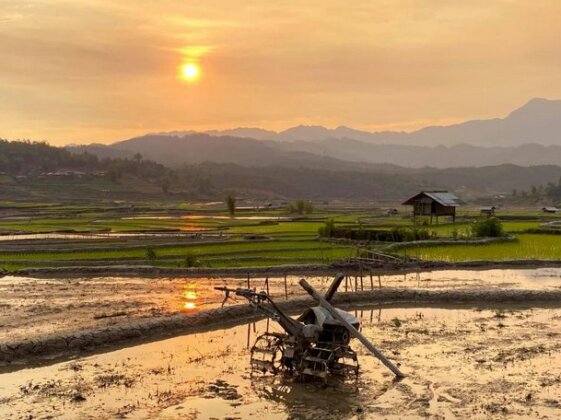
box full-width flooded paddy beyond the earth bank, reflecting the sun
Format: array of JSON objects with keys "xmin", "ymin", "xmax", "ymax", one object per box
[{"xmin": 0, "ymin": 268, "xmax": 561, "ymax": 341}]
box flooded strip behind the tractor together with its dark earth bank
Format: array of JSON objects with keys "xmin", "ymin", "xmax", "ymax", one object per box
[{"xmin": 0, "ymin": 268, "xmax": 561, "ymax": 369}]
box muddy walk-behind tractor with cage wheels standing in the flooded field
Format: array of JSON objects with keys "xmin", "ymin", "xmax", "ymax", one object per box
[{"xmin": 216, "ymin": 274, "xmax": 404, "ymax": 381}]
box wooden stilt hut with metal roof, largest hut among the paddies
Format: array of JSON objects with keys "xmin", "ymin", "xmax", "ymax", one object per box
[{"xmin": 403, "ymin": 191, "xmax": 463, "ymax": 223}]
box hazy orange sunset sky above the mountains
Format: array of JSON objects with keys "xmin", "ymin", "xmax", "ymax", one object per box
[{"xmin": 0, "ymin": 0, "xmax": 561, "ymax": 144}]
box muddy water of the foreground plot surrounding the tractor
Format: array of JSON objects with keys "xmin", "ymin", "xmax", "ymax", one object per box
[{"xmin": 0, "ymin": 308, "xmax": 561, "ymax": 419}]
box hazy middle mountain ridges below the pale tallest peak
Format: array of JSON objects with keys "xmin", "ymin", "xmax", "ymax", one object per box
[{"xmin": 67, "ymin": 133, "xmax": 561, "ymax": 170}]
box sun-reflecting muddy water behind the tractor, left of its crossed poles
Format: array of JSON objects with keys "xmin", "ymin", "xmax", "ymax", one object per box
[{"xmin": 0, "ymin": 276, "xmax": 331, "ymax": 341}]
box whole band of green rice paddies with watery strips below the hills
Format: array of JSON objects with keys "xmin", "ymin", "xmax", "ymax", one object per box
[{"xmin": 0, "ymin": 202, "xmax": 561, "ymax": 271}]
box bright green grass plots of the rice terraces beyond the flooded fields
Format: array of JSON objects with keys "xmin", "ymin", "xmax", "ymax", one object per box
[{"xmin": 0, "ymin": 201, "xmax": 561, "ymax": 270}]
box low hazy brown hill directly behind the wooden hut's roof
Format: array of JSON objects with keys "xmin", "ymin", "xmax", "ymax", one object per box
[{"xmin": 177, "ymin": 163, "xmax": 561, "ymax": 200}]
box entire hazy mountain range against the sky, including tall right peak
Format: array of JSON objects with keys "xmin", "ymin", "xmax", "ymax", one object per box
[{"xmin": 68, "ymin": 98, "xmax": 561, "ymax": 170}]
